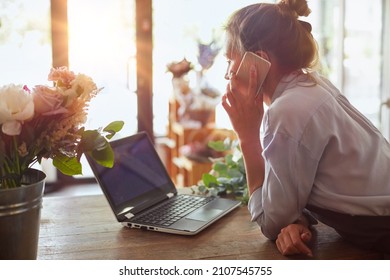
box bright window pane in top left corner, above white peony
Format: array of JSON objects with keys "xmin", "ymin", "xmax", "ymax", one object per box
[{"xmin": 0, "ymin": 0, "xmax": 52, "ymax": 87}]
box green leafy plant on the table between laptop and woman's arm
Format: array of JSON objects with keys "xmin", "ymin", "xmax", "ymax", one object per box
[{"xmin": 198, "ymin": 138, "xmax": 249, "ymax": 204}]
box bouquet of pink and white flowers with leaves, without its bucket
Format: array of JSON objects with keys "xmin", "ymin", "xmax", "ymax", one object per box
[{"xmin": 0, "ymin": 67, "xmax": 123, "ymax": 189}]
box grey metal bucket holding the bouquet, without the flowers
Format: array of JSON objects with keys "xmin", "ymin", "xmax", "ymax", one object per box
[{"xmin": 0, "ymin": 169, "xmax": 46, "ymax": 260}]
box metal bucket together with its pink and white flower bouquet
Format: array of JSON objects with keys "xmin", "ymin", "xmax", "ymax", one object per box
[{"xmin": 0, "ymin": 67, "xmax": 123, "ymax": 259}]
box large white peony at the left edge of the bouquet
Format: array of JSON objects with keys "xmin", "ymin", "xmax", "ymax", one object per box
[{"xmin": 0, "ymin": 84, "xmax": 34, "ymax": 135}]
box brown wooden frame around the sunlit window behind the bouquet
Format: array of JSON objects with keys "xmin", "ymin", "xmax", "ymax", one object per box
[{"xmin": 46, "ymin": 0, "xmax": 154, "ymax": 188}]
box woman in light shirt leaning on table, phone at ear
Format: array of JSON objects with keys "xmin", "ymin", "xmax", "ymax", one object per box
[{"xmin": 222, "ymin": 0, "xmax": 390, "ymax": 256}]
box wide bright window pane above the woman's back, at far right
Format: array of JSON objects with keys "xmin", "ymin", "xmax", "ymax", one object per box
[{"xmin": 342, "ymin": 0, "xmax": 382, "ymax": 126}]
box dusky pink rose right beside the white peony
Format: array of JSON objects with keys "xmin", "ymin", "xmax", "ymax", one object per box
[{"xmin": 32, "ymin": 86, "xmax": 68, "ymax": 116}]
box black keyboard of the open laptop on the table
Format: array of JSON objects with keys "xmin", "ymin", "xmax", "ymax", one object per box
[{"xmin": 132, "ymin": 195, "xmax": 215, "ymax": 226}]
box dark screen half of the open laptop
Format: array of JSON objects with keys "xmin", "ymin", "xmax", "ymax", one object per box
[{"xmin": 87, "ymin": 132, "xmax": 176, "ymax": 218}]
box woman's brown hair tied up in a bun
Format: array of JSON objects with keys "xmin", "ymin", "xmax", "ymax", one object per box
[{"xmin": 226, "ymin": 0, "xmax": 318, "ymax": 72}]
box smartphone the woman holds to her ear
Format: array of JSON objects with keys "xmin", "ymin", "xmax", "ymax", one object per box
[{"xmin": 236, "ymin": 52, "xmax": 271, "ymax": 97}]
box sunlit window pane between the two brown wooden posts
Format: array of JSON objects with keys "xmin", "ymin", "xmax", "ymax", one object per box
[{"xmin": 68, "ymin": 0, "xmax": 137, "ymax": 177}]
